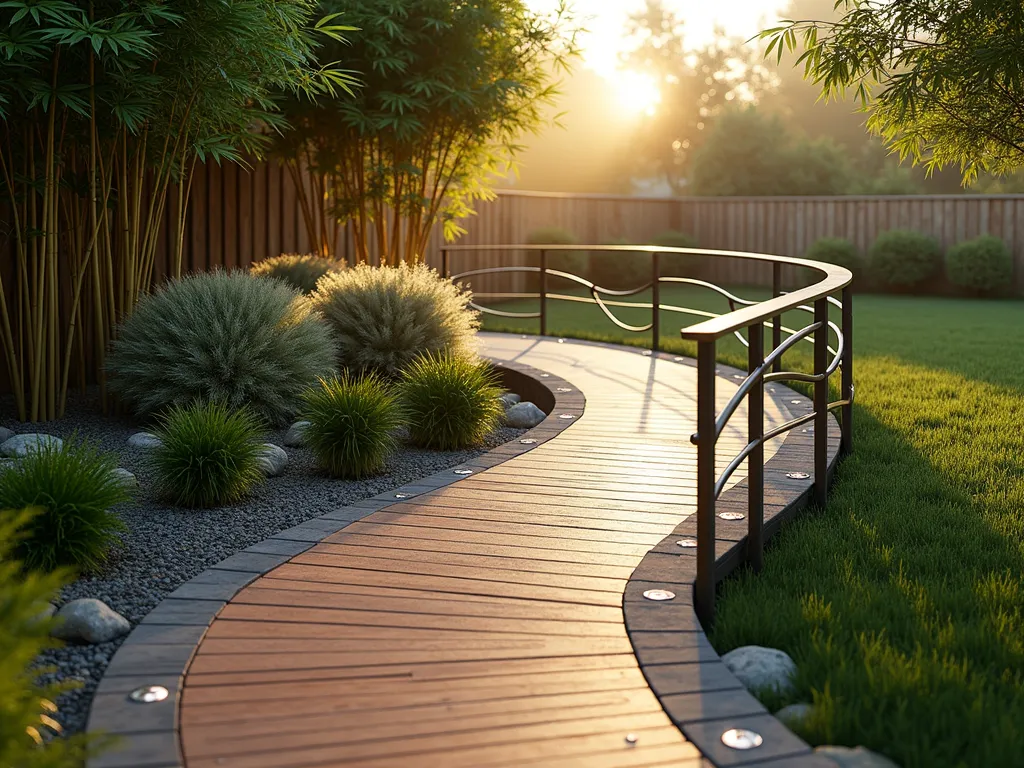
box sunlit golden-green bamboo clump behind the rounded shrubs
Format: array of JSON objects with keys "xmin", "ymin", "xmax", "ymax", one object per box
[{"xmin": 278, "ymin": 0, "xmax": 577, "ymax": 264}]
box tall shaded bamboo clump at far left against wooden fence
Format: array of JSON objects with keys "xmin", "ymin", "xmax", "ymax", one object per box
[{"xmin": 0, "ymin": 0, "xmax": 351, "ymax": 421}]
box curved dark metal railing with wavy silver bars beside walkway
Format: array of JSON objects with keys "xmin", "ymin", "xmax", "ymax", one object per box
[{"xmin": 441, "ymin": 245, "xmax": 854, "ymax": 626}]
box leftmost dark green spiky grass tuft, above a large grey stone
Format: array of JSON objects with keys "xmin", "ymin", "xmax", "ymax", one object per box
[{"xmin": 0, "ymin": 439, "xmax": 130, "ymax": 570}]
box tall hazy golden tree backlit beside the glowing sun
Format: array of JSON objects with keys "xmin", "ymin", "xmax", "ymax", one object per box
[{"xmin": 623, "ymin": 0, "xmax": 771, "ymax": 195}]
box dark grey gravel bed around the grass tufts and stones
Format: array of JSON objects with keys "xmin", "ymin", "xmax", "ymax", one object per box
[{"xmin": 0, "ymin": 397, "xmax": 525, "ymax": 733}]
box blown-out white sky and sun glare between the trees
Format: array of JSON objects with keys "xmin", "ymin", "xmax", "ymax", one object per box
[{"xmin": 527, "ymin": 0, "xmax": 786, "ymax": 116}]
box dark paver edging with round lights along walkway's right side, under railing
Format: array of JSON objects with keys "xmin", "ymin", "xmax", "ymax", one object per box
[{"xmin": 623, "ymin": 355, "xmax": 840, "ymax": 768}]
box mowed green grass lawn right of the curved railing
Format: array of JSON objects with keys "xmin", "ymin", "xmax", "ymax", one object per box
[{"xmin": 484, "ymin": 290, "xmax": 1024, "ymax": 768}]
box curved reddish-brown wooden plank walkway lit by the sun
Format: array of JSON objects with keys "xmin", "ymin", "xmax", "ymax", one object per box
[{"xmin": 178, "ymin": 335, "xmax": 798, "ymax": 768}]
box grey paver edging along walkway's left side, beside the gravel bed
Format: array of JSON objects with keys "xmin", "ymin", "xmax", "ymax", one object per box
[{"xmin": 86, "ymin": 359, "xmax": 586, "ymax": 768}]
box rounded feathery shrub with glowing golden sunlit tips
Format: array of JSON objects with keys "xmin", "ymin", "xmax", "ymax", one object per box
[{"xmin": 310, "ymin": 264, "xmax": 480, "ymax": 378}]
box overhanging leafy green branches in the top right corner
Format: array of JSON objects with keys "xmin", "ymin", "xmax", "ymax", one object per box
[{"xmin": 762, "ymin": 0, "xmax": 1024, "ymax": 184}]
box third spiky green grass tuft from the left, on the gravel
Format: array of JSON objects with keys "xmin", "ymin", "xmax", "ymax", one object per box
[{"xmin": 302, "ymin": 374, "xmax": 402, "ymax": 480}]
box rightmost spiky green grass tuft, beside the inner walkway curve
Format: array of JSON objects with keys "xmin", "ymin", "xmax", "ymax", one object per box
[{"xmin": 398, "ymin": 354, "xmax": 504, "ymax": 451}]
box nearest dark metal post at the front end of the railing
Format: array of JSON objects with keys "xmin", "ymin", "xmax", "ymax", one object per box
[{"xmin": 694, "ymin": 339, "xmax": 716, "ymax": 628}]
